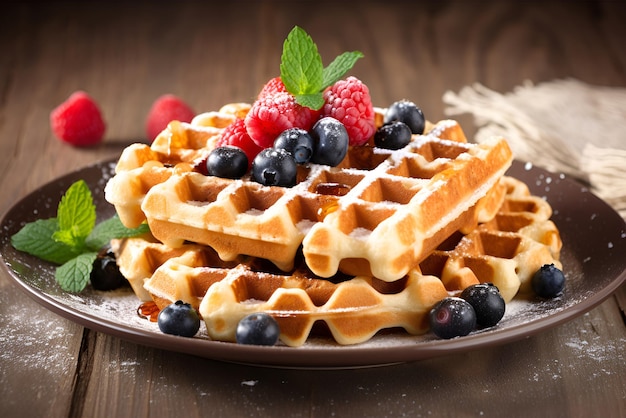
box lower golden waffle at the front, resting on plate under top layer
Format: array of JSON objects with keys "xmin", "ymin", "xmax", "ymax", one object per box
[{"xmin": 115, "ymin": 237, "xmax": 448, "ymax": 346}]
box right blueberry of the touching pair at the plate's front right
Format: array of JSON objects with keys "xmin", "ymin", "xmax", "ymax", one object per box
[{"xmin": 461, "ymin": 283, "xmax": 506, "ymax": 328}]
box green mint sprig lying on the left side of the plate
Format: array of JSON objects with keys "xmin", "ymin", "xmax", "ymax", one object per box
[{"xmin": 11, "ymin": 180, "xmax": 149, "ymax": 292}]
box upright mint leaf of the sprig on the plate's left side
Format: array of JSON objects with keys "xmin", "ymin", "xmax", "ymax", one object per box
[{"xmin": 54, "ymin": 180, "xmax": 96, "ymax": 243}]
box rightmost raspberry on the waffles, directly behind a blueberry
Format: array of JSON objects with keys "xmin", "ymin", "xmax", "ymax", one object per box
[{"xmin": 322, "ymin": 77, "xmax": 376, "ymax": 146}]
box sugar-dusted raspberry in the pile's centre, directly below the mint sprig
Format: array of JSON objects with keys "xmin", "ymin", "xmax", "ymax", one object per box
[{"xmin": 245, "ymin": 92, "xmax": 320, "ymax": 148}]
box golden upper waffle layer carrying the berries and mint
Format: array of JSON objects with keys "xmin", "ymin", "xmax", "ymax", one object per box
[{"xmin": 123, "ymin": 117, "xmax": 512, "ymax": 281}]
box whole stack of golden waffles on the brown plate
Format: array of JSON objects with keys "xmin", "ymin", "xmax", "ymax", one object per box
[{"xmin": 106, "ymin": 104, "xmax": 561, "ymax": 346}]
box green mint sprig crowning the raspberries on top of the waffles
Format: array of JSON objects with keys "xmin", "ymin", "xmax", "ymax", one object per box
[{"xmin": 280, "ymin": 26, "xmax": 363, "ymax": 110}]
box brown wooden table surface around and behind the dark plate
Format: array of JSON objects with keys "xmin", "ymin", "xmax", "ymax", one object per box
[{"xmin": 0, "ymin": 0, "xmax": 626, "ymax": 417}]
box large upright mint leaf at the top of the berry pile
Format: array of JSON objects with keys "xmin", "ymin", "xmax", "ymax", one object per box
[{"xmin": 280, "ymin": 26, "xmax": 324, "ymax": 96}]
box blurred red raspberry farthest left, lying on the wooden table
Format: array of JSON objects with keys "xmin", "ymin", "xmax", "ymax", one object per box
[{"xmin": 50, "ymin": 91, "xmax": 106, "ymax": 147}]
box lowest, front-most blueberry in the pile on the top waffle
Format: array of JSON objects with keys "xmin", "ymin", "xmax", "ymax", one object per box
[{"xmin": 252, "ymin": 148, "xmax": 298, "ymax": 187}]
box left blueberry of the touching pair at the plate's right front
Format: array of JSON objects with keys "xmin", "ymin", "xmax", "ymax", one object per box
[{"xmin": 428, "ymin": 297, "xmax": 476, "ymax": 339}]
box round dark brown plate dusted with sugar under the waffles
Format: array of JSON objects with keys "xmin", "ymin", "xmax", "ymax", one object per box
[{"xmin": 0, "ymin": 161, "xmax": 626, "ymax": 368}]
